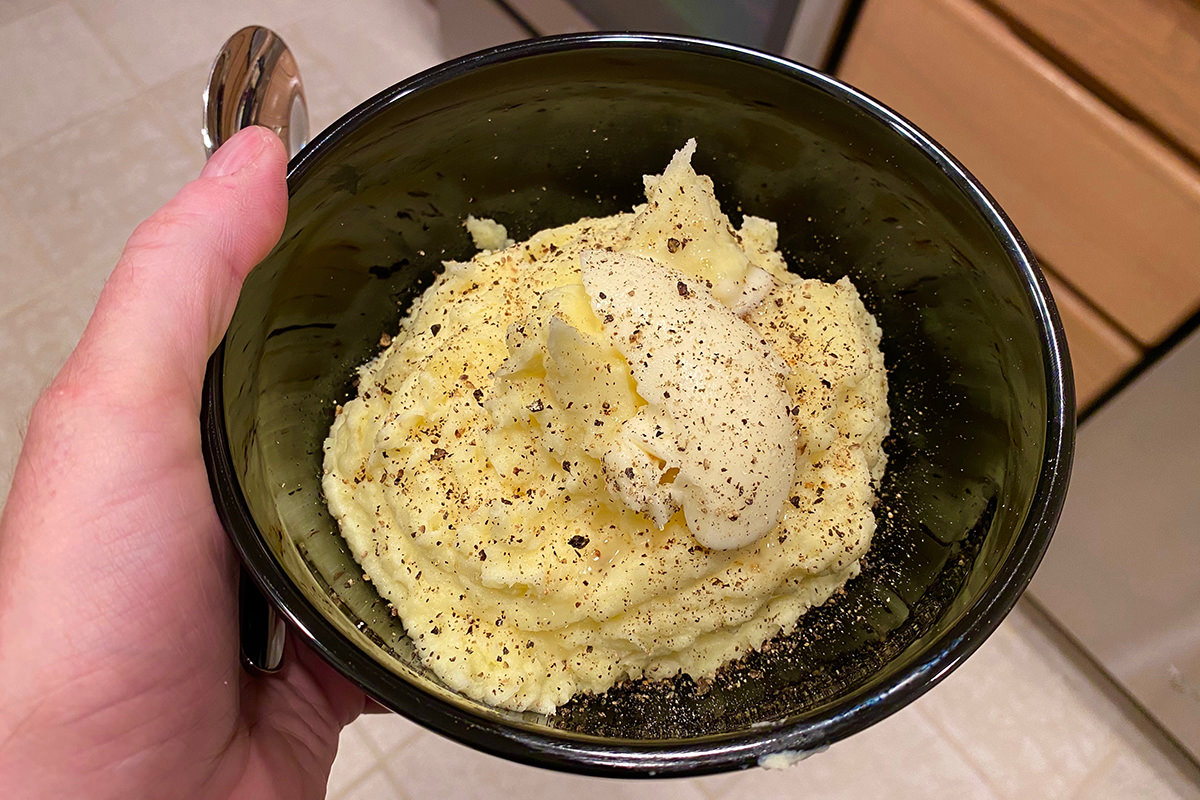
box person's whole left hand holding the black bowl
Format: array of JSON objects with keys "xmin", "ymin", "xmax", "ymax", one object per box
[{"xmin": 0, "ymin": 128, "xmax": 365, "ymax": 799}]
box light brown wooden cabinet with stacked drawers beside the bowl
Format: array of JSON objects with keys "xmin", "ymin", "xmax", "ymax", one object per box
[{"xmin": 838, "ymin": 0, "xmax": 1200, "ymax": 405}]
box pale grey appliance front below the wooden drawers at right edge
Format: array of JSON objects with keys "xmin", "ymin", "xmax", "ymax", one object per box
[{"xmin": 1031, "ymin": 332, "xmax": 1200, "ymax": 772}]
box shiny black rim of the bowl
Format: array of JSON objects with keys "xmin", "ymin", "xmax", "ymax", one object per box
[{"xmin": 200, "ymin": 32, "xmax": 1075, "ymax": 777}]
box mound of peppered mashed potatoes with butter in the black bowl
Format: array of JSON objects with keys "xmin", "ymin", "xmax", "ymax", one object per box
[{"xmin": 324, "ymin": 142, "xmax": 888, "ymax": 712}]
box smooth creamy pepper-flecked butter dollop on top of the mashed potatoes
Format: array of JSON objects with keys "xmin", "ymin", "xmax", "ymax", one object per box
[{"xmin": 581, "ymin": 251, "xmax": 796, "ymax": 549}]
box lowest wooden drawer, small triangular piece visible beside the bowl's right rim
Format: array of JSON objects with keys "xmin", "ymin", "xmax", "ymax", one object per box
[{"xmin": 1046, "ymin": 273, "xmax": 1141, "ymax": 409}]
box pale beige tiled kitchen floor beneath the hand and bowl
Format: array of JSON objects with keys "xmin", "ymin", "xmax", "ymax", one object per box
[{"xmin": 0, "ymin": 0, "xmax": 1200, "ymax": 800}]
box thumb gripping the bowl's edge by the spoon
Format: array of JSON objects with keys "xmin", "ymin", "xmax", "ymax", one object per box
[{"xmin": 65, "ymin": 127, "xmax": 288, "ymax": 405}]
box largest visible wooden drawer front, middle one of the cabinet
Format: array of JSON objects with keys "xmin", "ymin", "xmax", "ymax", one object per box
[{"xmin": 840, "ymin": 0, "xmax": 1200, "ymax": 344}]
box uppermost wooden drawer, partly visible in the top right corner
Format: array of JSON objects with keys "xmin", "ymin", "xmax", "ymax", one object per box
[{"xmin": 991, "ymin": 0, "xmax": 1200, "ymax": 156}]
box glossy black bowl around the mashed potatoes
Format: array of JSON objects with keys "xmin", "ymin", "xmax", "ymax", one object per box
[{"xmin": 204, "ymin": 35, "xmax": 1074, "ymax": 776}]
